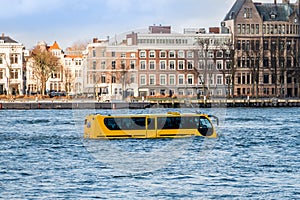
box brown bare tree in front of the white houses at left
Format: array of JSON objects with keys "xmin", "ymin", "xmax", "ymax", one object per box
[{"xmin": 31, "ymin": 46, "xmax": 60, "ymax": 95}]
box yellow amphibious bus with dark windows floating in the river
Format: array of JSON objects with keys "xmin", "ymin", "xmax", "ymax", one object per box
[{"xmin": 84, "ymin": 112, "xmax": 218, "ymax": 139}]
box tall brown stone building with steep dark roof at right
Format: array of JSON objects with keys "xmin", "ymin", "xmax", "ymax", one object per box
[{"xmin": 222, "ymin": 0, "xmax": 300, "ymax": 97}]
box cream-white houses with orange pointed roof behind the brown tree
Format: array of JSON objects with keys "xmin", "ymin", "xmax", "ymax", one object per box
[{"xmin": 25, "ymin": 41, "xmax": 84, "ymax": 95}]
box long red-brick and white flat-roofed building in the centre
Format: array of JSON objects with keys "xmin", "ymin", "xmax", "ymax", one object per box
[{"xmin": 84, "ymin": 26, "xmax": 232, "ymax": 99}]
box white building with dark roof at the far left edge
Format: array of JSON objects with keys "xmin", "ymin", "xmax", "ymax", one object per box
[{"xmin": 0, "ymin": 34, "xmax": 25, "ymax": 95}]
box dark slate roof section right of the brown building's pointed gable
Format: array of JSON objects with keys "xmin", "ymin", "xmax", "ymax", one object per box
[{"xmin": 255, "ymin": 4, "xmax": 294, "ymax": 21}]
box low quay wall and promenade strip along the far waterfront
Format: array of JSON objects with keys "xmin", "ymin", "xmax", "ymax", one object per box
[{"xmin": 0, "ymin": 98, "xmax": 300, "ymax": 110}]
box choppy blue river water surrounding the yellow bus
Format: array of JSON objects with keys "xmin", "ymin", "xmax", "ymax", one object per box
[{"xmin": 0, "ymin": 108, "xmax": 300, "ymax": 199}]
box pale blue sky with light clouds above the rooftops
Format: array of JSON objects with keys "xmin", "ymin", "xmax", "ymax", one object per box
[{"xmin": 0, "ymin": 0, "xmax": 293, "ymax": 49}]
